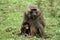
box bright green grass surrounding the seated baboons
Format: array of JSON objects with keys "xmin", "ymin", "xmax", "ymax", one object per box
[{"xmin": 0, "ymin": 0, "xmax": 60, "ymax": 40}]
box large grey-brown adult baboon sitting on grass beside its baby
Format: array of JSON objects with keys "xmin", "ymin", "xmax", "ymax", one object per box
[{"xmin": 22, "ymin": 5, "xmax": 45, "ymax": 37}]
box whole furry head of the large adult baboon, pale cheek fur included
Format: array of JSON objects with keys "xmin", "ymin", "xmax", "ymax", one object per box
[{"xmin": 26, "ymin": 7, "xmax": 40, "ymax": 19}]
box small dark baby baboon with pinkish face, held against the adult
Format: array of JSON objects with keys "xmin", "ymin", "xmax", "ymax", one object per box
[{"xmin": 21, "ymin": 22, "xmax": 30, "ymax": 36}]
